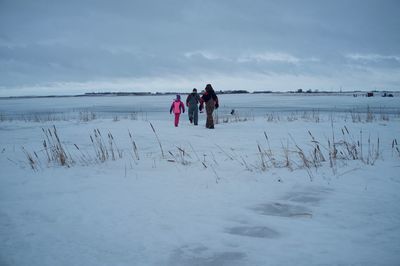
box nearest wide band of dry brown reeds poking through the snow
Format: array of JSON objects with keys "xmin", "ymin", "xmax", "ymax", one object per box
[{"xmin": 22, "ymin": 122, "xmax": 394, "ymax": 183}]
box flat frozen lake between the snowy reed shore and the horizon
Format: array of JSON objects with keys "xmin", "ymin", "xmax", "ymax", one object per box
[{"xmin": 0, "ymin": 93, "xmax": 400, "ymax": 120}]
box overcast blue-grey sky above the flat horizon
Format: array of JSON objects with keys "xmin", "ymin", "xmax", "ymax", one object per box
[{"xmin": 0, "ymin": 0, "xmax": 400, "ymax": 96}]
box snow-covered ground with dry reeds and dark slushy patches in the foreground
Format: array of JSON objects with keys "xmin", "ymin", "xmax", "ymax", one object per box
[{"xmin": 0, "ymin": 96, "xmax": 400, "ymax": 266}]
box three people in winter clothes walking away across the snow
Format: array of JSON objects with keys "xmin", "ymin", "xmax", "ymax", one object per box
[{"xmin": 169, "ymin": 84, "xmax": 219, "ymax": 129}]
